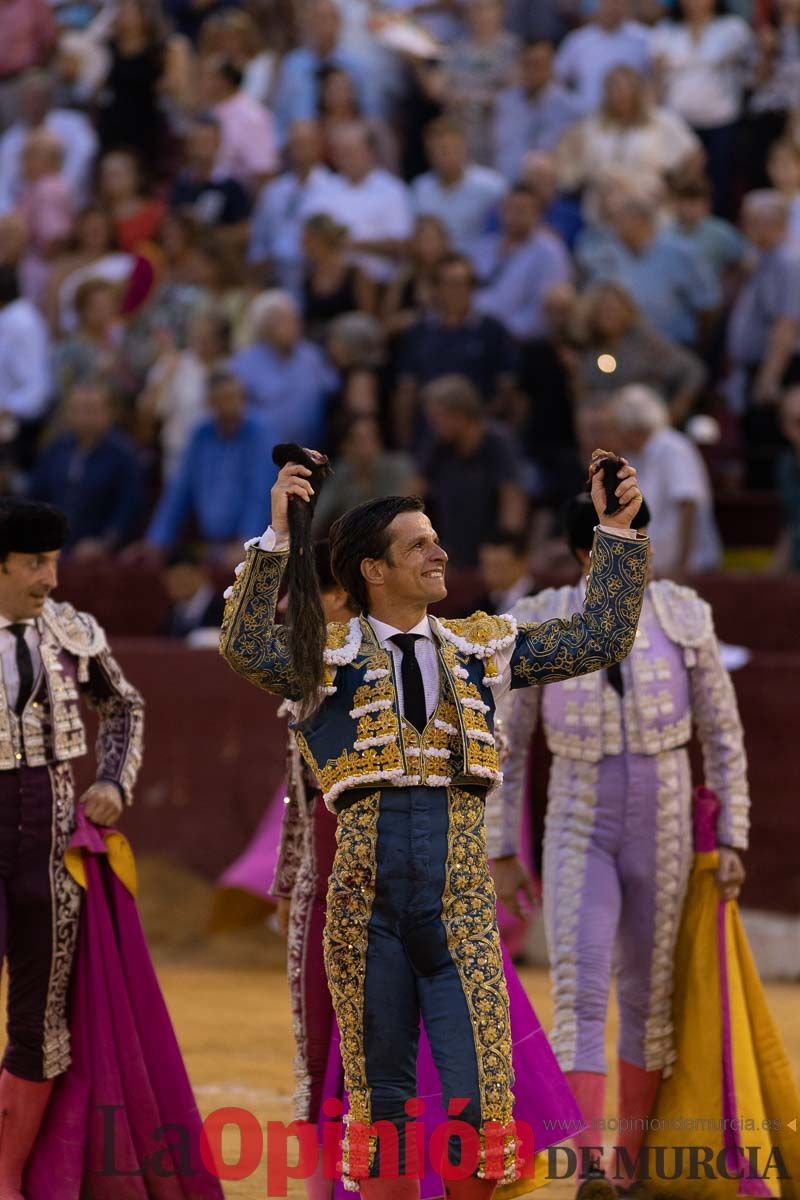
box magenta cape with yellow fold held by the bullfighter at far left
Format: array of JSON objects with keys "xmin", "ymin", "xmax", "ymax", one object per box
[{"xmin": 25, "ymin": 809, "xmax": 223, "ymax": 1200}]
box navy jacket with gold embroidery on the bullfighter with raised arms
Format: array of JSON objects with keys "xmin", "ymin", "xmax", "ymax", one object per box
[{"xmin": 219, "ymin": 532, "xmax": 648, "ymax": 808}]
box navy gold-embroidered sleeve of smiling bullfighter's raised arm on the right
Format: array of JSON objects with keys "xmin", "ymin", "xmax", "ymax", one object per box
[{"xmin": 510, "ymin": 532, "xmax": 648, "ymax": 688}]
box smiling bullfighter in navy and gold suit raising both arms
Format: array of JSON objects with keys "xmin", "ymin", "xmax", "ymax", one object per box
[{"xmin": 219, "ymin": 451, "xmax": 648, "ymax": 1200}]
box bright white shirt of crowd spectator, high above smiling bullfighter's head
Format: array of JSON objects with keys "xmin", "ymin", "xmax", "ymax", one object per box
[{"xmin": 301, "ymin": 167, "xmax": 414, "ymax": 283}]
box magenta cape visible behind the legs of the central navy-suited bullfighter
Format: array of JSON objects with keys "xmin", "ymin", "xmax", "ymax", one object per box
[{"xmin": 320, "ymin": 949, "xmax": 587, "ymax": 1200}]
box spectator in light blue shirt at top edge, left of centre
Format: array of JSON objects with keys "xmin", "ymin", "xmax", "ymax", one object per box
[{"xmin": 275, "ymin": 0, "xmax": 380, "ymax": 138}]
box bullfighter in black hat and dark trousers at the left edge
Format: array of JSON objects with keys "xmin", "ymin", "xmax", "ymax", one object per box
[{"xmin": 0, "ymin": 500, "xmax": 143, "ymax": 1200}]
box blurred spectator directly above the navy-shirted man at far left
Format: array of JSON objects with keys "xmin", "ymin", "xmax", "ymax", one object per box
[{"xmin": 53, "ymin": 280, "xmax": 121, "ymax": 396}]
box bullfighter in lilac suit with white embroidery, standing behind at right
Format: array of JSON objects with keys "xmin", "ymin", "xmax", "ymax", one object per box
[{"xmin": 488, "ymin": 496, "xmax": 748, "ymax": 1198}]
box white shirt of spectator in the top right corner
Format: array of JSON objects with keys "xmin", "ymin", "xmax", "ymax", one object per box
[{"xmin": 650, "ymin": 16, "xmax": 754, "ymax": 130}]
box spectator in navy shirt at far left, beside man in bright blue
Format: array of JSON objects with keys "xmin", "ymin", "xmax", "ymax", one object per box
[{"xmin": 29, "ymin": 379, "xmax": 143, "ymax": 562}]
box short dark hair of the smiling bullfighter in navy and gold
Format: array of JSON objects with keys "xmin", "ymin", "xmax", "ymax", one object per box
[{"xmin": 330, "ymin": 496, "xmax": 425, "ymax": 612}]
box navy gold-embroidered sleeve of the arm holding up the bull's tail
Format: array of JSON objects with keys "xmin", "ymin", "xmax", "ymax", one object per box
[{"xmin": 219, "ymin": 546, "xmax": 300, "ymax": 700}]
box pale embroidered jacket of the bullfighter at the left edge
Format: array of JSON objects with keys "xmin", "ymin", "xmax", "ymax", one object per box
[{"xmin": 0, "ymin": 600, "xmax": 144, "ymax": 804}]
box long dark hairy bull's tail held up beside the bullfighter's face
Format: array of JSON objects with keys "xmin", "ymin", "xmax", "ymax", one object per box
[{"xmin": 272, "ymin": 442, "xmax": 331, "ymax": 719}]
